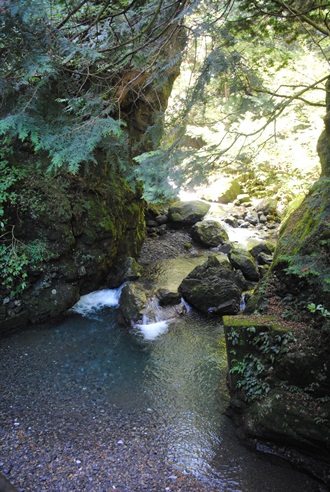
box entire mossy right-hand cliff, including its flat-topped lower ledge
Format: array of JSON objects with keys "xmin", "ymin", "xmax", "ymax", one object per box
[{"xmin": 226, "ymin": 80, "xmax": 330, "ymax": 485}]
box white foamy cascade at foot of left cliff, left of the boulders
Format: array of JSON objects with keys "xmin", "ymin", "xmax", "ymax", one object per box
[{"xmin": 71, "ymin": 286, "xmax": 122, "ymax": 316}]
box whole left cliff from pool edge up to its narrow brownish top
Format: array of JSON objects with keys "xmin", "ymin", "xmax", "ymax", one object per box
[{"xmin": 0, "ymin": 25, "xmax": 186, "ymax": 335}]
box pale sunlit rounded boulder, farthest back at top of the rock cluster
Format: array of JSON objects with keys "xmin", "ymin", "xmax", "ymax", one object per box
[{"xmin": 168, "ymin": 200, "xmax": 211, "ymax": 225}]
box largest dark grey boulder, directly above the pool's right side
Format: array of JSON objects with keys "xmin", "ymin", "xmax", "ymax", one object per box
[{"xmin": 179, "ymin": 255, "xmax": 242, "ymax": 315}]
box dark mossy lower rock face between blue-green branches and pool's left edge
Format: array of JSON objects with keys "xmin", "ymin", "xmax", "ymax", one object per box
[{"xmin": 0, "ymin": 168, "xmax": 145, "ymax": 333}]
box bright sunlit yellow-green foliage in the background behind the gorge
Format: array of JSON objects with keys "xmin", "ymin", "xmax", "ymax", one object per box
[{"xmin": 135, "ymin": 0, "xmax": 330, "ymax": 200}]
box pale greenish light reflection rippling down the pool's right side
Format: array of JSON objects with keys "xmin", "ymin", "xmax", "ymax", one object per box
[{"xmin": 143, "ymin": 315, "xmax": 226, "ymax": 475}]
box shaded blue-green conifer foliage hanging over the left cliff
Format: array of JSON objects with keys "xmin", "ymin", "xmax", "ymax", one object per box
[{"xmin": 0, "ymin": 0, "xmax": 185, "ymax": 173}]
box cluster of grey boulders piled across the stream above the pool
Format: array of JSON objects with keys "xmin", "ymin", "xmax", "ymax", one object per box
[{"xmin": 120, "ymin": 201, "xmax": 274, "ymax": 325}]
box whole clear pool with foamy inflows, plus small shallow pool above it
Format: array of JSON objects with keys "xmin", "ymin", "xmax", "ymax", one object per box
[{"xmin": 0, "ymin": 259, "xmax": 322, "ymax": 492}]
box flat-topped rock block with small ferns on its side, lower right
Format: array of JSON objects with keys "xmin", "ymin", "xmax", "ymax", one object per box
[{"xmin": 223, "ymin": 315, "xmax": 330, "ymax": 485}]
